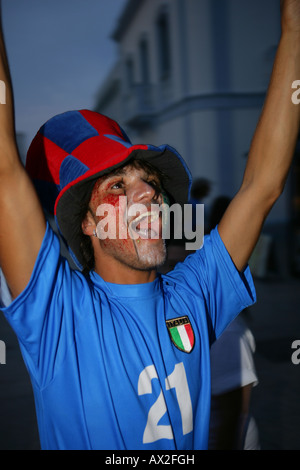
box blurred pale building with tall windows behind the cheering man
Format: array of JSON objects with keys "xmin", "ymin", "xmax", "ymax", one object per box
[{"xmin": 96, "ymin": 0, "xmax": 300, "ymax": 278}]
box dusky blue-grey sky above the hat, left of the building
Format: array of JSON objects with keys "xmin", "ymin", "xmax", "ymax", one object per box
[{"xmin": 2, "ymin": 0, "xmax": 127, "ymax": 151}]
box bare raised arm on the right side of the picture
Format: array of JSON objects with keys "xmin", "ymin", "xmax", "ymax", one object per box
[{"xmin": 219, "ymin": 0, "xmax": 300, "ymax": 270}]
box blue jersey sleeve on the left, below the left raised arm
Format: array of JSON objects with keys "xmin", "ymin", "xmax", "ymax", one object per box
[{"xmin": 1, "ymin": 224, "xmax": 72, "ymax": 387}]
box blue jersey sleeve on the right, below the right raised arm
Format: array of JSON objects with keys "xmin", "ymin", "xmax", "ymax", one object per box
[{"xmin": 166, "ymin": 227, "xmax": 256, "ymax": 342}]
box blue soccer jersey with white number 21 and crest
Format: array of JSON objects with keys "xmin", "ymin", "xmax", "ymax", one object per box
[{"xmin": 3, "ymin": 226, "xmax": 255, "ymax": 450}]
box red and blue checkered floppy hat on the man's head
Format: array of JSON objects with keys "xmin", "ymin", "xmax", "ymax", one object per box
[{"xmin": 26, "ymin": 110, "xmax": 192, "ymax": 267}]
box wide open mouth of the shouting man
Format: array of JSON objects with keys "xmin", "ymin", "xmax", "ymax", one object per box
[{"xmin": 128, "ymin": 211, "xmax": 160, "ymax": 239}]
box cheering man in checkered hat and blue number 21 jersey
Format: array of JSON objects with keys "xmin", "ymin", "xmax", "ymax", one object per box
[{"xmin": 0, "ymin": 0, "xmax": 300, "ymax": 450}]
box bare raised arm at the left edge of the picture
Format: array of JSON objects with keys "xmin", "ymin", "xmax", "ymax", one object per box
[{"xmin": 0, "ymin": 5, "xmax": 45, "ymax": 297}]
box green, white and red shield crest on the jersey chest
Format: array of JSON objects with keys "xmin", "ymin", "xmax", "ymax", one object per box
[{"xmin": 166, "ymin": 315, "xmax": 195, "ymax": 353}]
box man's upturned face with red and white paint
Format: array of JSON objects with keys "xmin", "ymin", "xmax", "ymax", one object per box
[{"xmin": 89, "ymin": 165, "xmax": 166, "ymax": 270}]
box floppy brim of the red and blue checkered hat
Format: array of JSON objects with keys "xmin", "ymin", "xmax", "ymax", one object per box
[{"xmin": 55, "ymin": 145, "xmax": 192, "ymax": 269}]
